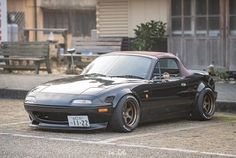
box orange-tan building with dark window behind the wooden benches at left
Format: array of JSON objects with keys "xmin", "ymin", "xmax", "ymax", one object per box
[{"xmin": 7, "ymin": 0, "xmax": 96, "ymax": 46}]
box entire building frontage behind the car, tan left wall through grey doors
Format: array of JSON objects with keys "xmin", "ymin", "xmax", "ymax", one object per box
[{"xmin": 7, "ymin": 0, "xmax": 236, "ymax": 71}]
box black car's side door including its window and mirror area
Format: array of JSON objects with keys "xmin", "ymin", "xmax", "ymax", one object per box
[{"xmin": 143, "ymin": 58, "xmax": 197, "ymax": 121}]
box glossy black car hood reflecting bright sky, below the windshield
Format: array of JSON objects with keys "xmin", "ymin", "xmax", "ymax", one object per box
[{"xmin": 33, "ymin": 76, "xmax": 144, "ymax": 95}]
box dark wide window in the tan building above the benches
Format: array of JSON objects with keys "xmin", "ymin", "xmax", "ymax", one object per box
[{"xmin": 43, "ymin": 9, "xmax": 96, "ymax": 36}]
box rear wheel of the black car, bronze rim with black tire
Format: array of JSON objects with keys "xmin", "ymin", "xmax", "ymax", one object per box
[{"xmin": 192, "ymin": 88, "xmax": 216, "ymax": 121}]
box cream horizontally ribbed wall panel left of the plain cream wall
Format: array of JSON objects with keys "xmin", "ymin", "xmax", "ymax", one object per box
[{"xmin": 96, "ymin": 0, "xmax": 128, "ymax": 37}]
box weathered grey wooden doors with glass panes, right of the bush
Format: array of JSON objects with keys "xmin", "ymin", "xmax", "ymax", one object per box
[{"xmin": 168, "ymin": 0, "xmax": 236, "ymax": 70}]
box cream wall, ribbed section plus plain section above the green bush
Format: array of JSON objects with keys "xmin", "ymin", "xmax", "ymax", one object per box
[{"xmin": 96, "ymin": 0, "xmax": 169, "ymax": 37}]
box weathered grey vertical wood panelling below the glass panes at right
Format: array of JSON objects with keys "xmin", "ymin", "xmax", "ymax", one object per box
[{"xmin": 168, "ymin": 37, "xmax": 236, "ymax": 71}]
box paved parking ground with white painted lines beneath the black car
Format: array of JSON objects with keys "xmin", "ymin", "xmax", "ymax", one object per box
[{"xmin": 0, "ymin": 99, "xmax": 236, "ymax": 158}]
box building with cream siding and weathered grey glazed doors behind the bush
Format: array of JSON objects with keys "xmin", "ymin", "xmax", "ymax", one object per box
[{"xmin": 96, "ymin": 0, "xmax": 236, "ymax": 71}]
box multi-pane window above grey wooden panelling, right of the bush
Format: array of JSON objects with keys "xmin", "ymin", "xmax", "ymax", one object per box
[{"xmin": 171, "ymin": 0, "xmax": 220, "ymax": 36}]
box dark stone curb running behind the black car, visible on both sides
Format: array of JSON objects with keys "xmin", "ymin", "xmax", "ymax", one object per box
[{"xmin": 0, "ymin": 89, "xmax": 236, "ymax": 113}]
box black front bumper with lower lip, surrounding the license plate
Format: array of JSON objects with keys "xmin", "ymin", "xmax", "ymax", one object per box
[{"xmin": 24, "ymin": 104, "xmax": 113, "ymax": 130}]
